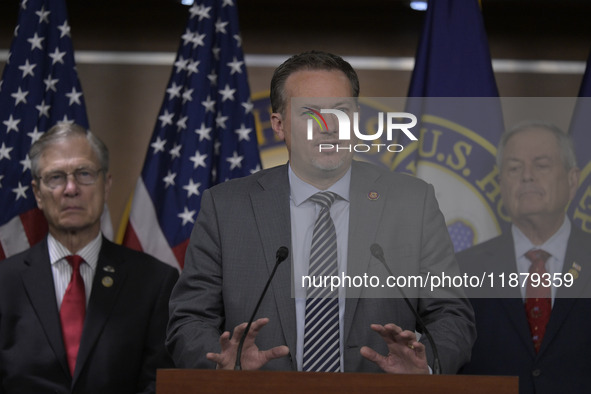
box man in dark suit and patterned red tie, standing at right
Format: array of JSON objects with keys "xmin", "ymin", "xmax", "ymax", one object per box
[{"xmin": 458, "ymin": 122, "xmax": 591, "ymax": 394}]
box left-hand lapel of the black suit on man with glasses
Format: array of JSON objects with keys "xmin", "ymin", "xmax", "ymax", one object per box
[{"xmin": 23, "ymin": 240, "xmax": 70, "ymax": 376}]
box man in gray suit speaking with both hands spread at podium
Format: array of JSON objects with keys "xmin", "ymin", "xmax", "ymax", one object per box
[{"xmin": 167, "ymin": 52, "xmax": 475, "ymax": 373}]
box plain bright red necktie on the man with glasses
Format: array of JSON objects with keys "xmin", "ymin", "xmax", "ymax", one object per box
[{"xmin": 60, "ymin": 255, "xmax": 86, "ymax": 376}]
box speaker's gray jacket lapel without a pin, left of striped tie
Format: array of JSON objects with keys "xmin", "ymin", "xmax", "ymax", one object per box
[{"xmin": 250, "ymin": 165, "xmax": 296, "ymax": 369}]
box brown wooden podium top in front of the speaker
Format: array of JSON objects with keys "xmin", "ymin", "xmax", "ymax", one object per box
[{"xmin": 156, "ymin": 369, "xmax": 518, "ymax": 394}]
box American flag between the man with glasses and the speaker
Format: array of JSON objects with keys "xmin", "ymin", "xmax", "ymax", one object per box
[{"xmin": 123, "ymin": 0, "xmax": 261, "ymax": 268}]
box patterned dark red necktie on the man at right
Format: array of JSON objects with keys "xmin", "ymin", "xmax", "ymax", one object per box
[{"xmin": 525, "ymin": 249, "xmax": 552, "ymax": 353}]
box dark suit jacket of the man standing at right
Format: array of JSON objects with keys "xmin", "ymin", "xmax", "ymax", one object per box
[{"xmin": 457, "ymin": 226, "xmax": 591, "ymax": 394}]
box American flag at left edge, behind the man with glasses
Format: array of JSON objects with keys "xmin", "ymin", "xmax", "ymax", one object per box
[{"xmin": 0, "ymin": 0, "xmax": 88, "ymax": 260}]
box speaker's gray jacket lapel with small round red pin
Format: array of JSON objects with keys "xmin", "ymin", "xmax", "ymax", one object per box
[{"xmin": 344, "ymin": 162, "xmax": 388, "ymax": 340}]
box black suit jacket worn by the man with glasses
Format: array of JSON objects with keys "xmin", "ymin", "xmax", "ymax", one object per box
[{"xmin": 0, "ymin": 238, "xmax": 178, "ymax": 394}]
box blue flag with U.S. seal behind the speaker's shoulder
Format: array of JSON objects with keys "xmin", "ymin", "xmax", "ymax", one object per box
[{"xmin": 392, "ymin": 0, "xmax": 506, "ymax": 252}]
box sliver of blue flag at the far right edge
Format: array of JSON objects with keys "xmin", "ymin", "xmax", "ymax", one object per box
[{"xmin": 567, "ymin": 49, "xmax": 591, "ymax": 233}]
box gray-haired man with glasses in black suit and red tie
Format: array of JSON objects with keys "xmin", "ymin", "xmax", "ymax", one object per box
[{"xmin": 0, "ymin": 123, "xmax": 178, "ymax": 394}]
